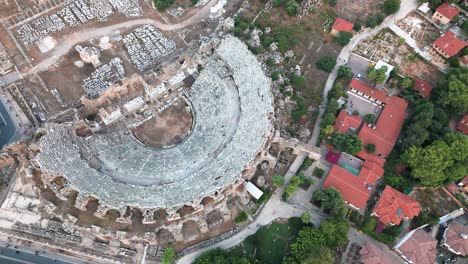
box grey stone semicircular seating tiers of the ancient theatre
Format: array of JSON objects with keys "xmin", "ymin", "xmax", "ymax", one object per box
[{"xmin": 36, "ymin": 36, "xmax": 273, "ymax": 208}]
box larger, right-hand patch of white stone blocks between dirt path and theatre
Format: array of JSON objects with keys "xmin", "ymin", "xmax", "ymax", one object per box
[{"xmin": 123, "ymin": 25, "xmax": 175, "ymax": 71}]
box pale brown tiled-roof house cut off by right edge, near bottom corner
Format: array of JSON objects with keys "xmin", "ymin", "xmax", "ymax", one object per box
[{"xmin": 442, "ymin": 222, "xmax": 468, "ymax": 256}]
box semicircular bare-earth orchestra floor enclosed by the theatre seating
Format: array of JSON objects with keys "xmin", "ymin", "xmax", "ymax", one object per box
[{"xmin": 133, "ymin": 100, "xmax": 192, "ymax": 148}]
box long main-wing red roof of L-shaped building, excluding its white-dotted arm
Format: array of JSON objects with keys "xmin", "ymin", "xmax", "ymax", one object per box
[{"xmin": 358, "ymin": 96, "xmax": 408, "ymax": 157}]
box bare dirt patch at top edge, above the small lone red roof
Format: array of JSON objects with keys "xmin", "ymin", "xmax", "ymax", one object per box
[{"xmin": 333, "ymin": 0, "xmax": 384, "ymax": 25}]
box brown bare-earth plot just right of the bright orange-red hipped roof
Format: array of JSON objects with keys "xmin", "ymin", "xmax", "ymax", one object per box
[{"xmin": 411, "ymin": 188, "xmax": 459, "ymax": 216}]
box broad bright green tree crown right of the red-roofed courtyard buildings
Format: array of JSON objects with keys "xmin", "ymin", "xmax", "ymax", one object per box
[{"xmin": 405, "ymin": 140, "xmax": 453, "ymax": 186}]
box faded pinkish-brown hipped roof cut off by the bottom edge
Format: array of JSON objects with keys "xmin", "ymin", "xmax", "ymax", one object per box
[{"xmin": 398, "ymin": 229, "xmax": 437, "ymax": 264}]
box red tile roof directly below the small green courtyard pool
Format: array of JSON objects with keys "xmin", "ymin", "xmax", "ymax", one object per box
[{"xmin": 323, "ymin": 162, "xmax": 382, "ymax": 209}]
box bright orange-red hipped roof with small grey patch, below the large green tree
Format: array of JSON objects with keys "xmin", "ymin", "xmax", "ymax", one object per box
[{"xmin": 373, "ymin": 185, "xmax": 421, "ymax": 225}]
